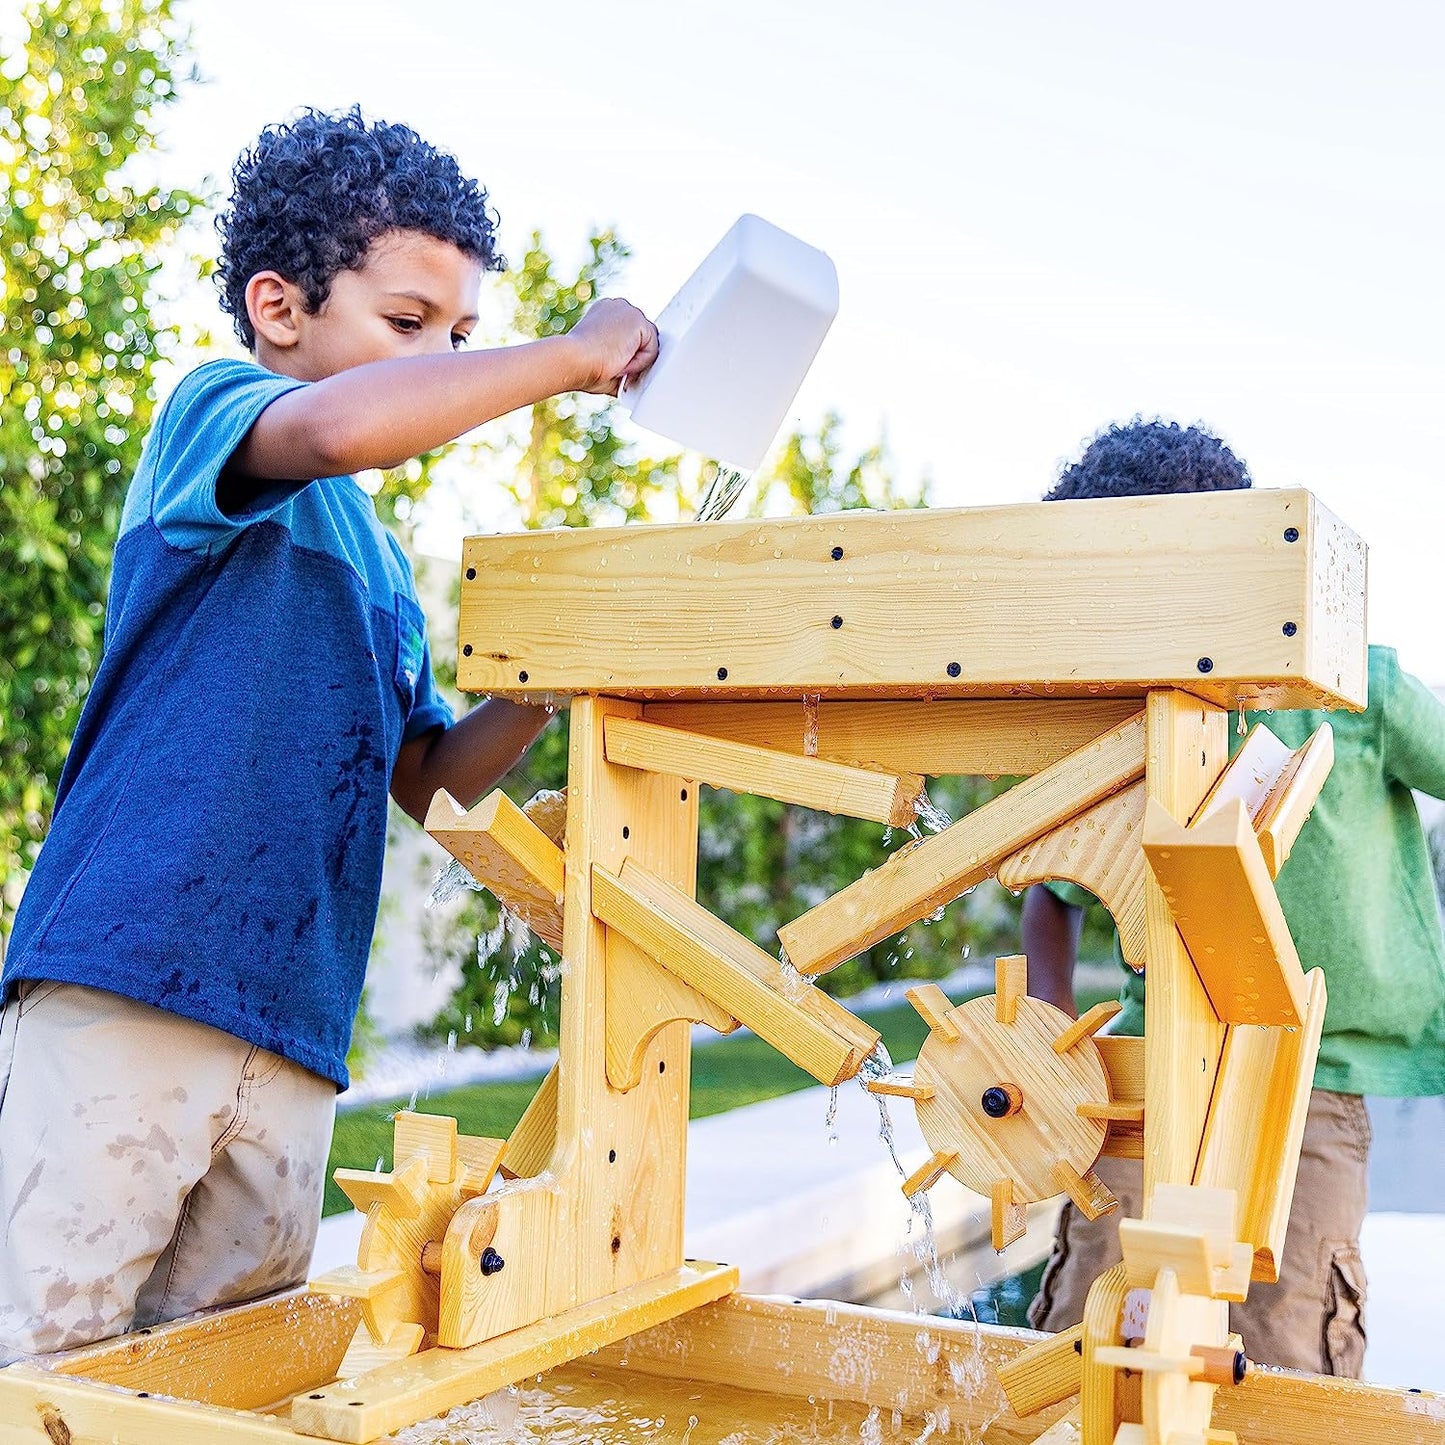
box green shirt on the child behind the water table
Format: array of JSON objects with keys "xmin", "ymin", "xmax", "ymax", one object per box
[{"xmin": 1051, "ymin": 647, "xmax": 1445, "ymax": 1097}]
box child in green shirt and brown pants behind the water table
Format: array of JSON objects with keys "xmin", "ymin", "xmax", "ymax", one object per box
[{"xmin": 1023, "ymin": 418, "xmax": 1445, "ymax": 1377}]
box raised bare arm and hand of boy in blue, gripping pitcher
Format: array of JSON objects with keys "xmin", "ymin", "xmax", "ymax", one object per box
[{"xmin": 227, "ymin": 298, "xmax": 657, "ymax": 481}]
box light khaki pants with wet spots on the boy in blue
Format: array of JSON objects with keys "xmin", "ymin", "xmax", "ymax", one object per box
[{"xmin": 0, "ymin": 983, "xmax": 337, "ymax": 1364}]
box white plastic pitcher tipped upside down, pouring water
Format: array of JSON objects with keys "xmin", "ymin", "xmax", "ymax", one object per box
[{"xmin": 618, "ymin": 215, "xmax": 838, "ymax": 471}]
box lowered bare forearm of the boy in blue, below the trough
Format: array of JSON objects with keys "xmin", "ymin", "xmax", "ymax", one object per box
[{"xmin": 392, "ymin": 698, "xmax": 552, "ymax": 822}]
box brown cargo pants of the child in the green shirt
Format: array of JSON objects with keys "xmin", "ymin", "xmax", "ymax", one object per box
[{"xmin": 1029, "ymin": 1088, "xmax": 1370, "ymax": 1380}]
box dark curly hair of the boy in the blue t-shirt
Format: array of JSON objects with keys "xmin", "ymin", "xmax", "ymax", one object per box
[{"xmin": 215, "ymin": 105, "xmax": 506, "ymax": 350}]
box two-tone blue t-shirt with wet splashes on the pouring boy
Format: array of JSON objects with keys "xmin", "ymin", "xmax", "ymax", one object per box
[{"xmin": 4, "ymin": 361, "xmax": 451, "ymax": 1088}]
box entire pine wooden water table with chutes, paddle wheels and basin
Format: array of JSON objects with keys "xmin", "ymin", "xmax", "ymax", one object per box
[{"xmin": 0, "ymin": 491, "xmax": 1445, "ymax": 1445}]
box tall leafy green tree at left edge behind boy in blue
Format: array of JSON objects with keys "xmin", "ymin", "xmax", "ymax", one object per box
[{"xmin": 0, "ymin": 0, "xmax": 197, "ymax": 933}]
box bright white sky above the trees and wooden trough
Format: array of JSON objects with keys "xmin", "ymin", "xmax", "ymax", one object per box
[{"xmin": 10, "ymin": 0, "xmax": 1445, "ymax": 683}]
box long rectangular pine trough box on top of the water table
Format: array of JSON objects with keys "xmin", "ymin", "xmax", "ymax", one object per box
[{"xmin": 458, "ymin": 490, "xmax": 1366, "ymax": 708}]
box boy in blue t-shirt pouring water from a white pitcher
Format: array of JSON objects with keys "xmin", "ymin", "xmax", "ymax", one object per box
[{"xmin": 0, "ymin": 110, "xmax": 657, "ymax": 1358}]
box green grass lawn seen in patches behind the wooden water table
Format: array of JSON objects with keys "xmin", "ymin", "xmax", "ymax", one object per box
[{"xmin": 322, "ymin": 985, "xmax": 1111, "ymax": 1214}]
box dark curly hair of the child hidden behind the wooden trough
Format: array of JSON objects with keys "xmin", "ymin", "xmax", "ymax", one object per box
[{"xmin": 1043, "ymin": 416, "xmax": 1253, "ymax": 501}]
